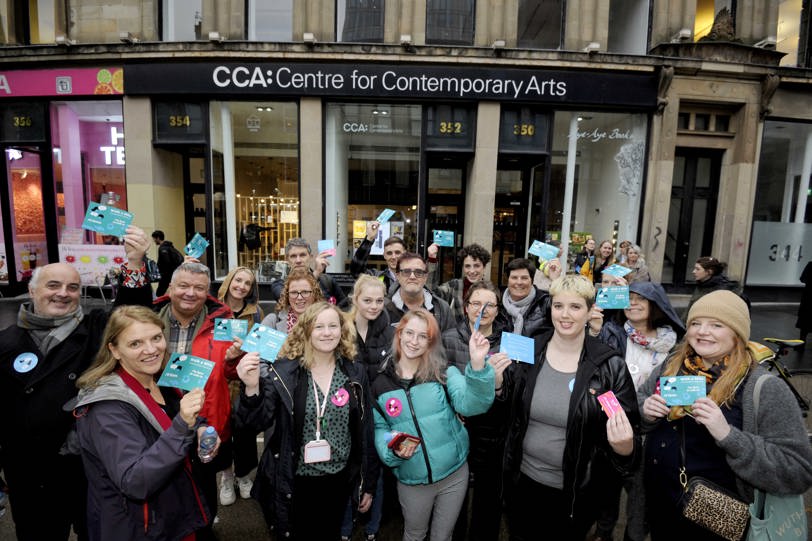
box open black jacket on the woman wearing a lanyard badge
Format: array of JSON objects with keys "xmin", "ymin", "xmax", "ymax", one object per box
[{"xmin": 233, "ymin": 358, "xmax": 379, "ymax": 538}]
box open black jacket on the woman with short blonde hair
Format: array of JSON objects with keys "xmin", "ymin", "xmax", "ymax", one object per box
[{"xmin": 503, "ymin": 331, "xmax": 641, "ymax": 510}]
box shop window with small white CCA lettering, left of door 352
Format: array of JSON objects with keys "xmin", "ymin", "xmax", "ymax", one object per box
[{"xmin": 324, "ymin": 104, "xmax": 422, "ymax": 270}]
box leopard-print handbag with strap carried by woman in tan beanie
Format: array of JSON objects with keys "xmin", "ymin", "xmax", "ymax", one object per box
[{"xmin": 679, "ymin": 427, "xmax": 750, "ymax": 541}]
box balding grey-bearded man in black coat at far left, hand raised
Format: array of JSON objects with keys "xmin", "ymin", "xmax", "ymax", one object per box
[{"xmin": 0, "ymin": 226, "xmax": 152, "ymax": 541}]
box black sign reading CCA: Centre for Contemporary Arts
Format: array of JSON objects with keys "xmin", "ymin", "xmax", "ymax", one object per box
[{"xmin": 124, "ymin": 62, "xmax": 657, "ymax": 109}]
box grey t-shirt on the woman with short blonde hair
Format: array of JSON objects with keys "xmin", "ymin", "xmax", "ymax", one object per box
[{"xmin": 521, "ymin": 359, "xmax": 575, "ymax": 489}]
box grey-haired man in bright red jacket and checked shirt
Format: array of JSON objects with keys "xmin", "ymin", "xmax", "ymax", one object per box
[{"xmin": 119, "ymin": 261, "xmax": 242, "ymax": 532}]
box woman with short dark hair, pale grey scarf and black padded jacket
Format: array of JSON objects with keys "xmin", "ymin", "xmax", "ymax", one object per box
[{"xmin": 500, "ymin": 258, "xmax": 550, "ymax": 338}]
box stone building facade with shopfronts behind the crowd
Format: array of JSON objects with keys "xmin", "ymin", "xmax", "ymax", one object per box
[{"xmin": 0, "ymin": 0, "xmax": 812, "ymax": 291}]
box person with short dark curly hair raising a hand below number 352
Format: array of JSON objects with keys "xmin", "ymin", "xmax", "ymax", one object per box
[{"xmin": 426, "ymin": 244, "xmax": 491, "ymax": 323}]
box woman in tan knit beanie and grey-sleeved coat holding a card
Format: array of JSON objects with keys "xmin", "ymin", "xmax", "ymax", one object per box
[{"xmin": 639, "ymin": 291, "xmax": 812, "ymax": 541}]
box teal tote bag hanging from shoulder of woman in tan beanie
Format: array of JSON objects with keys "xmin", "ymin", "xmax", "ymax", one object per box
[{"xmin": 747, "ymin": 374, "xmax": 808, "ymax": 541}]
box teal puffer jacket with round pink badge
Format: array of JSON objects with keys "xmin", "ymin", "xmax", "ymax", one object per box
[{"xmin": 372, "ymin": 359, "xmax": 494, "ymax": 485}]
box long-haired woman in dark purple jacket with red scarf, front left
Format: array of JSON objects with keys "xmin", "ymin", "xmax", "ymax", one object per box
[{"xmin": 73, "ymin": 306, "xmax": 211, "ymax": 540}]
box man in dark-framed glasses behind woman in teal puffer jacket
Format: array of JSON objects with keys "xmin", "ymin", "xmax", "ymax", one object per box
[{"xmin": 384, "ymin": 252, "xmax": 455, "ymax": 331}]
